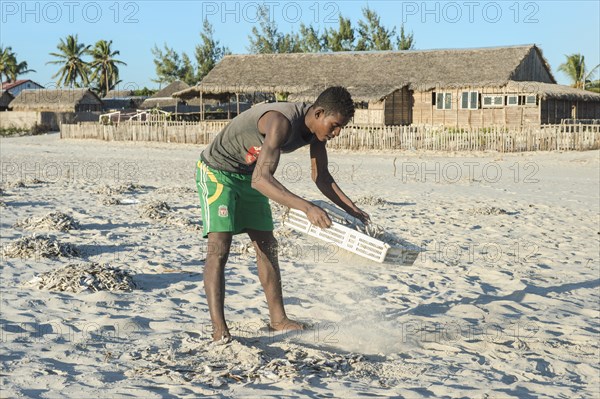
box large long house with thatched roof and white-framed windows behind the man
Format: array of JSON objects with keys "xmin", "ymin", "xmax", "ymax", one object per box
[{"xmin": 174, "ymin": 45, "xmax": 600, "ymax": 127}]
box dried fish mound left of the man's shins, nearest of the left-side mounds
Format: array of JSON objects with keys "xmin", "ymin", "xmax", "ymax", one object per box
[{"xmin": 28, "ymin": 262, "xmax": 136, "ymax": 293}]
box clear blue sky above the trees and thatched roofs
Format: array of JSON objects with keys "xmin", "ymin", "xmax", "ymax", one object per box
[{"xmin": 0, "ymin": 0, "xmax": 600, "ymax": 88}]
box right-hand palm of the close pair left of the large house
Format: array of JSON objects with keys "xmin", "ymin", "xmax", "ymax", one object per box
[{"xmin": 89, "ymin": 40, "xmax": 127, "ymax": 96}]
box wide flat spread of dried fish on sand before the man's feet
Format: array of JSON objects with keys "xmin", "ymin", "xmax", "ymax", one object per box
[{"xmin": 127, "ymin": 340, "xmax": 365, "ymax": 388}]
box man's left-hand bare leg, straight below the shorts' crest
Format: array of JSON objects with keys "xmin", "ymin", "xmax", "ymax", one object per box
[{"xmin": 204, "ymin": 233, "xmax": 232, "ymax": 341}]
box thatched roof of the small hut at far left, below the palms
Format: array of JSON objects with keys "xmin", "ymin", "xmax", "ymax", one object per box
[{"xmin": 10, "ymin": 89, "xmax": 102, "ymax": 112}]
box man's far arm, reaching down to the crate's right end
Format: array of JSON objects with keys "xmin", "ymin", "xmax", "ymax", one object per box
[{"xmin": 310, "ymin": 141, "xmax": 370, "ymax": 223}]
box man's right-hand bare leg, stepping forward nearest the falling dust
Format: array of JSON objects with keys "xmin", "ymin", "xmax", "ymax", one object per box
[{"xmin": 248, "ymin": 230, "xmax": 304, "ymax": 330}]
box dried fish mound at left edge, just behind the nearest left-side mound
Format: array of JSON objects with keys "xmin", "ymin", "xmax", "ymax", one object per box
[{"xmin": 2, "ymin": 235, "xmax": 79, "ymax": 258}]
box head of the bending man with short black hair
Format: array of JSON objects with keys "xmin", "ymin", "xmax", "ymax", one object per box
[{"xmin": 307, "ymin": 86, "xmax": 354, "ymax": 141}]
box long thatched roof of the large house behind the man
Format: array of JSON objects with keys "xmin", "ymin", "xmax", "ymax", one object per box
[{"xmin": 175, "ymin": 45, "xmax": 556, "ymax": 101}]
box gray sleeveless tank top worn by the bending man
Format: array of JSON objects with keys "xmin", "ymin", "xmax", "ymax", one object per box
[{"xmin": 201, "ymin": 103, "xmax": 316, "ymax": 174}]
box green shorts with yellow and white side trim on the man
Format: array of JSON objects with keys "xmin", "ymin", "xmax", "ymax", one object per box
[{"xmin": 196, "ymin": 161, "xmax": 273, "ymax": 237}]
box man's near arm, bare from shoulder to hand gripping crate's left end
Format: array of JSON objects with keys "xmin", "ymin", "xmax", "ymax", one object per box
[{"xmin": 252, "ymin": 111, "xmax": 331, "ymax": 228}]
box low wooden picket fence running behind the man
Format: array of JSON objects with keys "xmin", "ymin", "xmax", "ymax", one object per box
[{"xmin": 60, "ymin": 120, "xmax": 600, "ymax": 152}]
